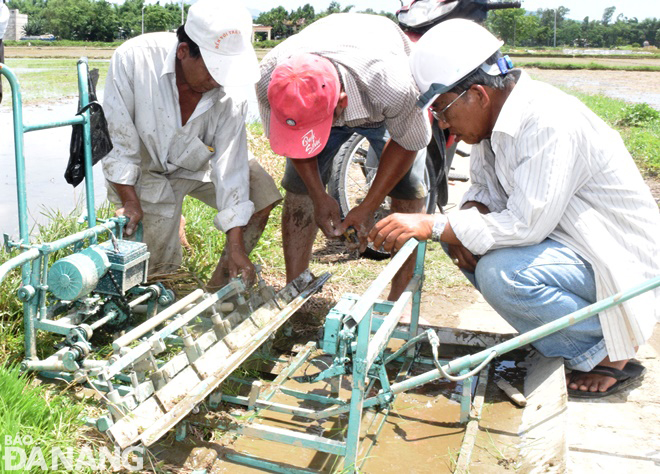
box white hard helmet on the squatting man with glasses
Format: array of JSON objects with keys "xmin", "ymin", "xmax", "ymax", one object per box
[{"xmin": 410, "ymin": 19, "xmax": 506, "ymax": 108}]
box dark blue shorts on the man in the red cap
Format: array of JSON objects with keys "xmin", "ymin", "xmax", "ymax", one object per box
[{"xmin": 282, "ymin": 126, "xmax": 428, "ymax": 200}]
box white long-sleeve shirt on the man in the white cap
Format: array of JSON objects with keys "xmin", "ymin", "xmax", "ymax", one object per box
[{"xmin": 103, "ymin": 33, "xmax": 254, "ymax": 232}]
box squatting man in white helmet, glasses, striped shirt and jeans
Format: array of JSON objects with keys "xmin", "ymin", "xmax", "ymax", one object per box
[{"xmin": 370, "ymin": 20, "xmax": 660, "ymax": 397}]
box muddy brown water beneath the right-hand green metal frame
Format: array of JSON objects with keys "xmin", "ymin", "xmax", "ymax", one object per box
[{"xmin": 160, "ymin": 356, "xmax": 464, "ymax": 474}]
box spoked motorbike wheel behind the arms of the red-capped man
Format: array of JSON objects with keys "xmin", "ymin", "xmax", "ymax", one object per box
[{"xmin": 328, "ymin": 133, "xmax": 437, "ymax": 260}]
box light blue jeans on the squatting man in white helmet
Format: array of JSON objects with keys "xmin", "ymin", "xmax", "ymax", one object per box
[{"xmin": 454, "ymin": 239, "xmax": 607, "ymax": 372}]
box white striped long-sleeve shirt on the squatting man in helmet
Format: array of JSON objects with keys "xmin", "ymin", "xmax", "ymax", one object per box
[{"xmin": 449, "ymin": 72, "xmax": 660, "ymax": 360}]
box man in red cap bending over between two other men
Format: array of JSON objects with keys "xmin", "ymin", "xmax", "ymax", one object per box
[{"xmin": 257, "ymin": 13, "xmax": 431, "ymax": 299}]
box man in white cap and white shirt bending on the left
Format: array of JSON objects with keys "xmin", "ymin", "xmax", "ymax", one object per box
[{"xmin": 103, "ymin": 0, "xmax": 281, "ymax": 289}]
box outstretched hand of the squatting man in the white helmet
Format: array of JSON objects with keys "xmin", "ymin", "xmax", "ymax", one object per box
[{"xmin": 369, "ymin": 214, "xmax": 434, "ymax": 252}]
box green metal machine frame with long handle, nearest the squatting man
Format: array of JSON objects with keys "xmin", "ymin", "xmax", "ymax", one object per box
[{"xmin": 208, "ymin": 239, "xmax": 660, "ymax": 473}]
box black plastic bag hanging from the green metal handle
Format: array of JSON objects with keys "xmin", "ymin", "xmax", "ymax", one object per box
[{"xmin": 64, "ymin": 69, "xmax": 112, "ymax": 188}]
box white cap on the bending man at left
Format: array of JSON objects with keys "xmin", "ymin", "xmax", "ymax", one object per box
[{"xmin": 184, "ymin": 0, "xmax": 260, "ymax": 86}]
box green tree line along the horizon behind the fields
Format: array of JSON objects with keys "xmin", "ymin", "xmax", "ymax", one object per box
[{"xmin": 7, "ymin": 0, "xmax": 660, "ymax": 48}]
